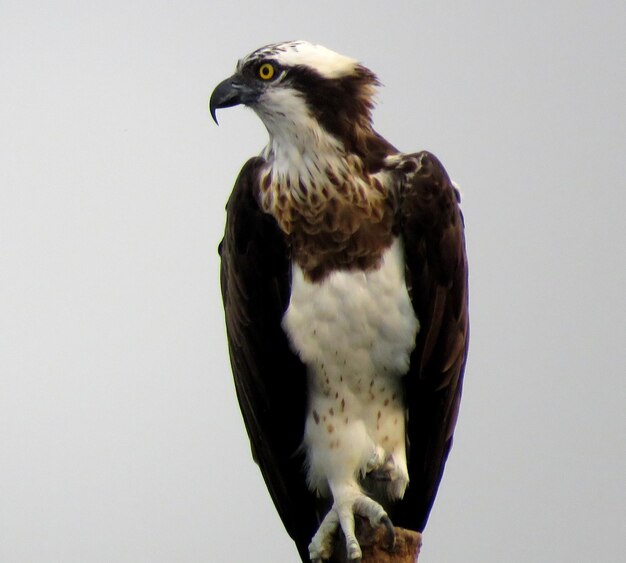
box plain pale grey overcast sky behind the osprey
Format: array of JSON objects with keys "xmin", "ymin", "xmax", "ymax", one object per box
[{"xmin": 0, "ymin": 0, "xmax": 626, "ymax": 563}]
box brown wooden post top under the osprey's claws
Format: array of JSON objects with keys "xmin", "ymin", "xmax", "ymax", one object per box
[{"xmin": 332, "ymin": 516, "xmax": 422, "ymax": 563}]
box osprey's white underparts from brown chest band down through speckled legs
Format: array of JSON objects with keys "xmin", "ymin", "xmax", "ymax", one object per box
[{"xmin": 283, "ymin": 240, "xmax": 419, "ymax": 493}]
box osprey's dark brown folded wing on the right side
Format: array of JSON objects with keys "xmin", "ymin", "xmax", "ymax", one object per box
[{"xmin": 391, "ymin": 152, "xmax": 469, "ymax": 531}]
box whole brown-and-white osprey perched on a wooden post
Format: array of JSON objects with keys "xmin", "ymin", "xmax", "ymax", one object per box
[{"xmin": 210, "ymin": 41, "xmax": 469, "ymax": 561}]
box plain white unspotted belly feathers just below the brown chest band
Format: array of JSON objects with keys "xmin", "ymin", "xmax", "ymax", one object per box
[{"xmin": 283, "ymin": 239, "xmax": 418, "ymax": 375}]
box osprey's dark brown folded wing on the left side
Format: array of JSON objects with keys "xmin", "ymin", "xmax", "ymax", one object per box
[{"xmin": 220, "ymin": 158, "xmax": 316, "ymax": 561}]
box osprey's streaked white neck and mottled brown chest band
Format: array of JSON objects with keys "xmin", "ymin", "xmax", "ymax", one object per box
[{"xmin": 258, "ymin": 123, "xmax": 394, "ymax": 280}]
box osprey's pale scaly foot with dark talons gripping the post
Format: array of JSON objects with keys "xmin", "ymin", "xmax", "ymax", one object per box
[{"xmin": 309, "ymin": 483, "xmax": 395, "ymax": 563}]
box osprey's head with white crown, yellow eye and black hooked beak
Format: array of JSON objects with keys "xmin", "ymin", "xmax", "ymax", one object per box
[{"xmin": 209, "ymin": 41, "xmax": 378, "ymax": 152}]
